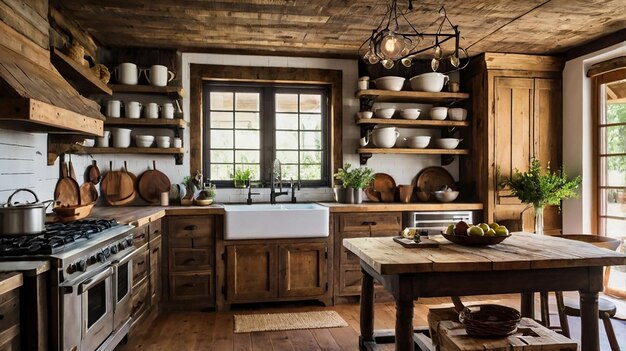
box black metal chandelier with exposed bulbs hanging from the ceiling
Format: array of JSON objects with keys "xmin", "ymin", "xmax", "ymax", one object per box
[{"xmin": 359, "ymin": 0, "xmax": 469, "ymax": 71}]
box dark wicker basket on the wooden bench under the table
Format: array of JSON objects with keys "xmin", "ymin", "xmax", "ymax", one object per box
[{"xmin": 459, "ymin": 305, "xmax": 522, "ymax": 338}]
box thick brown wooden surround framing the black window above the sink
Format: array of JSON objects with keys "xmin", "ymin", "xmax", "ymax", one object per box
[{"xmin": 189, "ymin": 64, "xmax": 343, "ymax": 184}]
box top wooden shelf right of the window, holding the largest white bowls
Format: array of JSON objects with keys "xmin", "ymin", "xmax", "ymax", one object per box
[{"xmin": 356, "ymin": 89, "xmax": 470, "ymax": 104}]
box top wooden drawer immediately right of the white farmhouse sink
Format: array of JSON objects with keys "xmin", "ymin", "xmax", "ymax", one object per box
[{"xmin": 339, "ymin": 212, "xmax": 402, "ymax": 236}]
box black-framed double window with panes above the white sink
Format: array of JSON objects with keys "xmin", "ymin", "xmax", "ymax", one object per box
[{"xmin": 203, "ymin": 82, "xmax": 330, "ymax": 187}]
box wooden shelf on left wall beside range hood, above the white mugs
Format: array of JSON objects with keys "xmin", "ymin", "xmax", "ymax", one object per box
[{"xmin": 50, "ymin": 47, "xmax": 113, "ymax": 95}]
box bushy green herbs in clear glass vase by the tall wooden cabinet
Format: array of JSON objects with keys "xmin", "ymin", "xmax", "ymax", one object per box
[{"xmin": 505, "ymin": 158, "xmax": 581, "ymax": 234}]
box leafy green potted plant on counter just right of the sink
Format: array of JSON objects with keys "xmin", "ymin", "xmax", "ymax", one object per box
[{"xmin": 334, "ymin": 163, "xmax": 374, "ymax": 204}]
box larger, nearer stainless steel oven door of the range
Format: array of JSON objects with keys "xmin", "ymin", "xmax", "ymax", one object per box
[{"xmin": 77, "ymin": 266, "xmax": 113, "ymax": 350}]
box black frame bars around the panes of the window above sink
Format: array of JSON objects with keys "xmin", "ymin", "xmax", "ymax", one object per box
[{"xmin": 202, "ymin": 80, "xmax": 332, "ymax": 187}]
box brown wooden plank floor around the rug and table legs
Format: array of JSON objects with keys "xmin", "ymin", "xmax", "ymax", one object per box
[{"xmin": 116, "ymin": 294, "xmax": 626, "ymax": 351}]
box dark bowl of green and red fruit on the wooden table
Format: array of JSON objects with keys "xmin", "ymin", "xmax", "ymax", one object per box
[{"xmin": 441, "ymin": 221, "xmax": 511, "ymax": 246}]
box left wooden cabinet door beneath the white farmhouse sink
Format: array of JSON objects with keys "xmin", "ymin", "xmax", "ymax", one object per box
[{"xmin": 226, "ymin": 244, "xmax": 278, "ymax": 302}]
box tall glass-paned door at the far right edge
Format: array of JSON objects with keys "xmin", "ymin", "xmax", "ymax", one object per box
[{"xmin": 598, "ymin": 74, "xmax": 626, "ymax": 297}]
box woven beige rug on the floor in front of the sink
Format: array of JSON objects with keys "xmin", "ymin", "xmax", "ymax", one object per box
[{"xmin": 234, "ymin": 311, "xmax": 348, "ymax": 333}]
